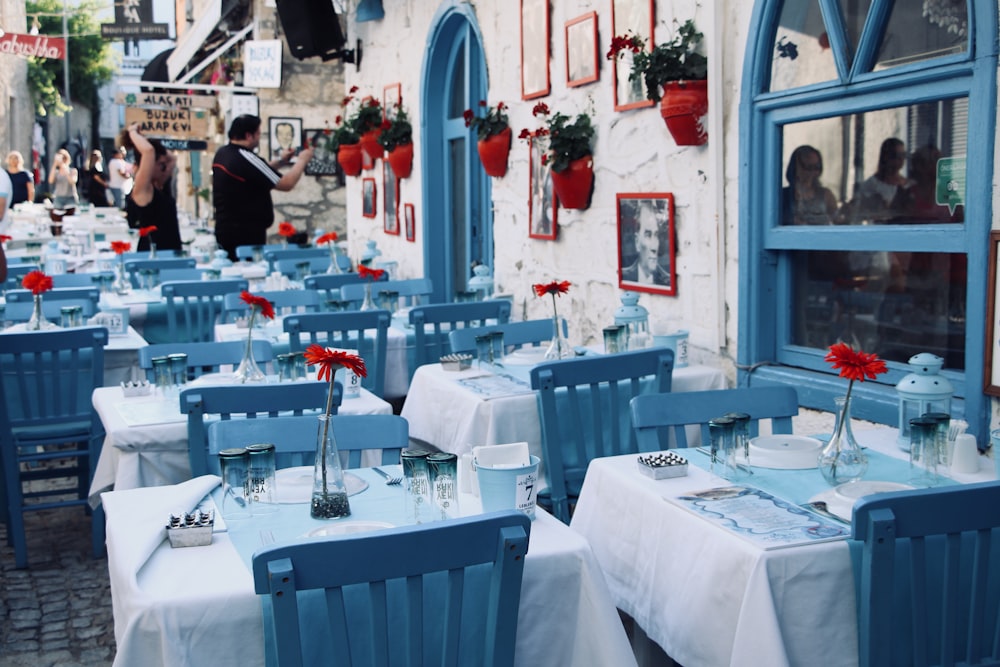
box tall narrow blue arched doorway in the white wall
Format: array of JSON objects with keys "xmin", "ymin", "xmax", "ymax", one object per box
[{"xmin": 420, "ymin": 0, "xmax": 493, "ymax": 301}]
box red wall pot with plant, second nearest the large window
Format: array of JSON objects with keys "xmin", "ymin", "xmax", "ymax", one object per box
[{"xmin": 519, "ymin": 102, "xmax": 594, "ymax": 209}]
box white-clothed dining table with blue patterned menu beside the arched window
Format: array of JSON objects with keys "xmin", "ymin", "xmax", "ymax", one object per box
[{"xmin": 570, "ymin": 427, "xmax": 996, "ymax": 667}]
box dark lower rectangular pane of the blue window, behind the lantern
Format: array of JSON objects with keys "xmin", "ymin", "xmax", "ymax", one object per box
[{"xmin": 791, "ymin": 251, "xmax": 966, "ymax": 370}]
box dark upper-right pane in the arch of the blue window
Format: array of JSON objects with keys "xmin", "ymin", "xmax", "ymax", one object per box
[{"xmin": 875, "ymin": 0, "xmax": 969, "ymax": 70}]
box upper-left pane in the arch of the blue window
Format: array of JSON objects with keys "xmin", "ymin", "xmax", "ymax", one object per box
[{"xmin": 771, "ymin": 0, "xmax": 838, "ymax": 91}]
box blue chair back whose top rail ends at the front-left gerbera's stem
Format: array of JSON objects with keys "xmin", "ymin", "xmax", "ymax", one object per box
[{"xmin": 180, "ymin": 382, "xmax": 332, "ymax": 477}]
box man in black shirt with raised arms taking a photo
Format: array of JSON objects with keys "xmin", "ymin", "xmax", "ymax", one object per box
[{"xmin": 212, "ymin": 115, "xmax": 313, "ymax": 261}]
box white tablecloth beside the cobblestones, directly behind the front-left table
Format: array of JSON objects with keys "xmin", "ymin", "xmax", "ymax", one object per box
[{"xmin": 90, "ymin": 387, "xmax": 392, "ymax": 506}]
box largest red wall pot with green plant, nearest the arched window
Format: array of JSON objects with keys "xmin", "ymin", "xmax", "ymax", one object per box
[{"xmin": 607, "ymin": 19, "xmax": 708, "ymax": 146}]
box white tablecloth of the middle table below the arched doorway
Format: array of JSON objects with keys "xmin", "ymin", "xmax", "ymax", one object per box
[{"xmin": 401, "ymin": 364, "xmax": 726, "ymax": 459}]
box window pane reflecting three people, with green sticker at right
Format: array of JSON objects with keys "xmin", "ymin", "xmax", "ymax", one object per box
[{"xmin": 781, "ymin": 98, "xmax": 968, "ymax": 225}]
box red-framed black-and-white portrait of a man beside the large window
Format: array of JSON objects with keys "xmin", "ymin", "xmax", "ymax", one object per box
[{"xmin": 617, "ymin": 192, "xmax": 677, "ymax": 296}]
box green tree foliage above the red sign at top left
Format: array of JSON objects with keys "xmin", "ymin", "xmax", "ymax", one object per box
[{"xmin": 25, "ymin": 0, "xmax": 115, "ymax": 116}]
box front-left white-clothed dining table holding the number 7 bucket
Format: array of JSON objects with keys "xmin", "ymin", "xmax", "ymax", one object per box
[{"xmin": 102, "ymin": 466, "xmax": 636, "ymax": 667}]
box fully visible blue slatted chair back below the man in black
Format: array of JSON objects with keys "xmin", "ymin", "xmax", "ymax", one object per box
[{"xmin": 160, "ymin": 280, "xmax": 248, "ymax": 343}]
